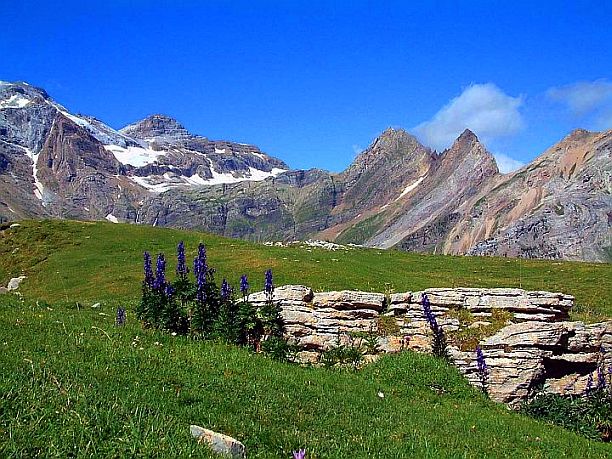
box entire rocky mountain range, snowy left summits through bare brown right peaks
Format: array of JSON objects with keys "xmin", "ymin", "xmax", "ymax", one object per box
[{"xmin": 0, "ymin": 83, "xmax": 612, "ymax": 261}]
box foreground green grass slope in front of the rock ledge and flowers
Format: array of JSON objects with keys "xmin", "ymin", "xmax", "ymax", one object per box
[{"xmin": 0, "ymin": 295, "xmax": 612, "ymax": 459}]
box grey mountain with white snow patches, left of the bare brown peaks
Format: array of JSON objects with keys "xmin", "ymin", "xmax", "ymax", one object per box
[{"xmin": 0, "ymin": 82, "xmax": 288, "ymax": 225}]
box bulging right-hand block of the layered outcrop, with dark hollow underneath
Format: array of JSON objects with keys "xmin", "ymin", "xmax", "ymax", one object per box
[{"xmin": 452, "ymin": 321, "xmax": 612, "ymax": 405}]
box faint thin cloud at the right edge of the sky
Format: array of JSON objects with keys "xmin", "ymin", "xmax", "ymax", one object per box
[{"xmin": 546, "ymin": 80, "xmax": 612, "ymax": 116}]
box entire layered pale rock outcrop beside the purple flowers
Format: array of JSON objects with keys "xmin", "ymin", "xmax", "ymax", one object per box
[{"xmin": 249, "ymin": 285, "xmax": 612, "ymax": 405}]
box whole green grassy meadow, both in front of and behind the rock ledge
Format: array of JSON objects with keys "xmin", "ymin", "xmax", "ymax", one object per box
[{"xmin": 0, "ymin": 221, "xmax": 612, "ymax": 459}]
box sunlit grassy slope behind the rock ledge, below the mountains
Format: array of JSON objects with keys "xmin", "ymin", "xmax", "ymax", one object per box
[{"xmin": 0, "ymin": 221, "xmax": 612, "ymax": 321}]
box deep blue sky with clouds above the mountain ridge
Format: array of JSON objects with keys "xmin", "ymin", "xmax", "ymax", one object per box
[{"xmin": 0, "ymin": 0, "xmax": 612, "ymax": 171}]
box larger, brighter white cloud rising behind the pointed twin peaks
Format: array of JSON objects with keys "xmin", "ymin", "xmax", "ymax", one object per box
[{"xmin": 412, "ymin": 83, "xmax": 525, "ymax": 150}]
